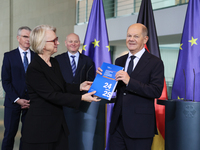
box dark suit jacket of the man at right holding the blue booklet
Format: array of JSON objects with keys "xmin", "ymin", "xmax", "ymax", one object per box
[{"xmin": 110, "ymin": 51, "xmax": 164, "ymax": 138}]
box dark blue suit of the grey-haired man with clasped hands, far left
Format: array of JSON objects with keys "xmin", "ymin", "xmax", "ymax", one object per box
[{"xmin": 1, "ymin": 48, "xmax": 34, "ymax": 150}]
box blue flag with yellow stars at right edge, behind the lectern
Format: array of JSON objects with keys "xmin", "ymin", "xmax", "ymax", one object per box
[{"xmin": 172, "ymin": 0, "xmax": 200, "ymax": 101}]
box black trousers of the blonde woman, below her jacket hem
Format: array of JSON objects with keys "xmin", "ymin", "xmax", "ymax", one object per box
[{"xmin": 22, "ymin": 129, "xmax": 69, "ymax": 150}]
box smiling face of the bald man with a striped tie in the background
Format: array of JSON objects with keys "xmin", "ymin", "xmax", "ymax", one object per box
[{"xmin": 65, "ymin": 33, "xmax": 80, "ymax": 54}]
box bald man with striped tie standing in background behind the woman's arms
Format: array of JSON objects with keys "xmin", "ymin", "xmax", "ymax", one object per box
[{"xmin": 55, "ymin": 33, "xmax": 95, "ymax": 150}]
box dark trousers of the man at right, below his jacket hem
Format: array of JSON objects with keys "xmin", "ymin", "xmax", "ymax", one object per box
[{"xmin": 110, "ymin": 119, "xmax": 153, "ymax": 150}]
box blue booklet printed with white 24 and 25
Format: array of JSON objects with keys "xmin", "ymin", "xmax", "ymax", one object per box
[{"xmin": 88, "ymin": 62, "xmax": 123, "ymax": 100}]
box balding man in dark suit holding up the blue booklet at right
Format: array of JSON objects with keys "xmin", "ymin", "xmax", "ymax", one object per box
[{"xmin": 97, "ymin": 23, "xmax": 164, "ymax": 150}]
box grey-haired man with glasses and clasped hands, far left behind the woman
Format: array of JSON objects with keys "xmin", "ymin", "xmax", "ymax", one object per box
[{"xmin": 1, "ymin": 26, "xmax": 34, "ymax": 150}]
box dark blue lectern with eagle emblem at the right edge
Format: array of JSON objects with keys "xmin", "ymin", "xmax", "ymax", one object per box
[{"xmin": 157, "ymin": 100, "xmax": 200, "ymax": 150}]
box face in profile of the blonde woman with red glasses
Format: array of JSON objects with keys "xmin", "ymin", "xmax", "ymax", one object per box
[{"xmin": 43, "ymin": 30, "xmax": 60, "ymax": 55}]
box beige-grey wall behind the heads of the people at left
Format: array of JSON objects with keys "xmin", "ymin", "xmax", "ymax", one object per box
[{"xmin": 0, "ymin": 0, "xmax": 76, "ymax": 76}]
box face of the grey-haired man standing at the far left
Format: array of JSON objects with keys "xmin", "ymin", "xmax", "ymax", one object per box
[{"xmin": 17, "ymin": 29, "xmax": 31, "ymax": 51}]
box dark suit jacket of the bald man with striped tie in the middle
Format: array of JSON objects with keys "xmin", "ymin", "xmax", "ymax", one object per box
[{"xmin": 55, "ymin": 52, "xmax": 95, "ymax": 84}]
